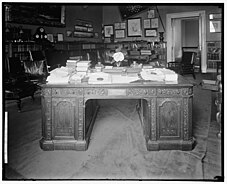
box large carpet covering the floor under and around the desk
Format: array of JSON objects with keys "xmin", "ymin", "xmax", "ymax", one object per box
[{"xmin": 3, "ymin": 83, "xmax": 211, "ymax": 180}]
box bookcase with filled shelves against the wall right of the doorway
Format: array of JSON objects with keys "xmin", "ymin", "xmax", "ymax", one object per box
[{"xmin": 207, "ymin": 41, "xmax": 221, "ymax": 73}]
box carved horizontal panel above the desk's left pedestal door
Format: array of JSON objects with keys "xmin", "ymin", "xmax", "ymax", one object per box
[{"xmin": 52, "ymin": 88, "xmax": 83, "ymax": 97}]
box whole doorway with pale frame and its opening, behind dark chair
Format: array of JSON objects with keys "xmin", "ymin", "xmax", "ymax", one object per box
[{"xmin": 166, "ymin": 11, "xmax": 207, "ymax": 73}]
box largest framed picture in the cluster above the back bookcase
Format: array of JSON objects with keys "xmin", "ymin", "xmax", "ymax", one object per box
[{"xmin": 127, "ymin": 18, "xmax": 142, "ymax": 37}]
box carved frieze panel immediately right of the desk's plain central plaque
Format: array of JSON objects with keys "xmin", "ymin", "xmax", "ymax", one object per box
[{"xmin": 127, "ymin": 88, "xmax": 156, "ymax": 96}]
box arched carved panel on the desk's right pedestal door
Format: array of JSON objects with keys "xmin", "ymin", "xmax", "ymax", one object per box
[{"xmin": 159, "ymin": 100, "xmax": 180, "ymax": 137}]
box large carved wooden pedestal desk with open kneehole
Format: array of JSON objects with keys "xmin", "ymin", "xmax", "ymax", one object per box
[{"xmin": 40, "ymin": 77, "xmax": 194, "ymax": 150}]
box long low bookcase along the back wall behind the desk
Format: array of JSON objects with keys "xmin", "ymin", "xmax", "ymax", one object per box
[{"xmin": 54, "ymin": 41, "xmax": 166, "ymax": 64}]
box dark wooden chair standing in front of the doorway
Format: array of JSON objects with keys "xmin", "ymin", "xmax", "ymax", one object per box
[{"xmin": 167, "ymin": 47, "xmax": 197, "ymax": 79}]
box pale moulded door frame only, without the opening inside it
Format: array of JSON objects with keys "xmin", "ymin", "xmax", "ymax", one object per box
[{"xmin": 166, "ymin": 11, "xmax": 207, "ymax": 73}]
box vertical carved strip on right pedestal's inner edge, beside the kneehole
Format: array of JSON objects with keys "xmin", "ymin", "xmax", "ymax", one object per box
[{"xmin": 148, "ymin": 98, "xmax": 157, "ymax": 141}]
